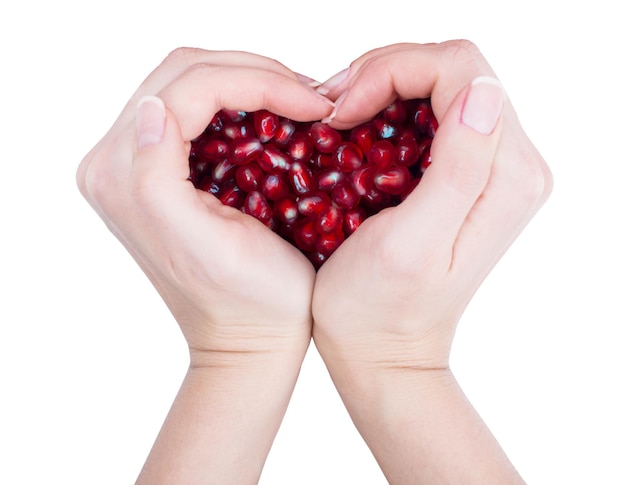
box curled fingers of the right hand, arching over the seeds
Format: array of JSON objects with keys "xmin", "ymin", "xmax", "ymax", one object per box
[{"xmin": 322, "ymin": 41, "xmax": 494, "ymax": 129}]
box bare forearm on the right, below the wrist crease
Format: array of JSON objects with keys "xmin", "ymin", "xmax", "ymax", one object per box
[{"xmin": 320, "ymin": 352, "xmax": 524, "ymax": 485}]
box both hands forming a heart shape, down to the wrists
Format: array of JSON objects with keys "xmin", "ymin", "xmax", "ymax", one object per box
[{"xmin": 77, "ymin": 41, "xmax": 551, "ymax": 482}]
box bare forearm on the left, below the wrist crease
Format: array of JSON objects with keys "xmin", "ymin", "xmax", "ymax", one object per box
[{"xmin": 137, "ymin": 346, "xmax": 304, "ymax": 485}]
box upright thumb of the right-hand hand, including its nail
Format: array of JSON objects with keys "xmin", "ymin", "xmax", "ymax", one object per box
[{"xmin": 395, "ymin": 77, "xmax": 505, "ymax": 253}]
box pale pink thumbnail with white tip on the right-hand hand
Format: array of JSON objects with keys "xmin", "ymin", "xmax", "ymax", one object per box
[{"xmin": 461, "ymin": 76, "xmax": 506, "ymax": 135}]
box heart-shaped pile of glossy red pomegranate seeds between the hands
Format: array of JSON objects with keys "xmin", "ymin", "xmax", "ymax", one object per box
[{"xmin": 189, "ymin": 99, "xmax": 438, "ymax": 268}]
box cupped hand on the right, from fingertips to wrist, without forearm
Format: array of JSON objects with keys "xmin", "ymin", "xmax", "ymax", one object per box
[{"xmin": 313, "ymin": 41, "xmax": 552, "ymax": 369}]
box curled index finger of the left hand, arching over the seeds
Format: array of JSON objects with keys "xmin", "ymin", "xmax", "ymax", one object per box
[{"xmin": 158, "ymin": 64, "xmax": 333, "ymax": 140}]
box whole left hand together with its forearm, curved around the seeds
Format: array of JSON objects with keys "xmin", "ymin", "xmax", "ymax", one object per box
[{"xmin": 77, "ymin": 49, "xmax": 332, "ymax": 484}]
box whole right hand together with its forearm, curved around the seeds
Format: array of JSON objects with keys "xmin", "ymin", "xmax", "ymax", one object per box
[{"xmin": 313, "ymin": 41, "xmax": 552, "ymax": 483}]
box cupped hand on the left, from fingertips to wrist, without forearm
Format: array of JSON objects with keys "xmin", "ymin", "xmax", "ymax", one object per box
[{"xmin": 77, "ymin": 49, "xmax": 332, "ymax": 364}]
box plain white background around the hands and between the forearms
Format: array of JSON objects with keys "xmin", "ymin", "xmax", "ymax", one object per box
[{"xmin": 0, "ymin": 0, "xmax": 626, "ymax": 485}]
